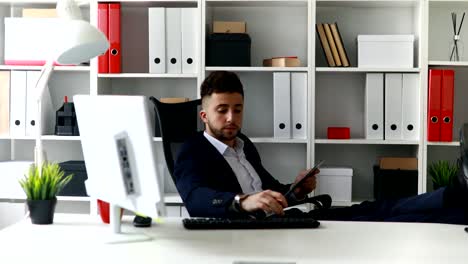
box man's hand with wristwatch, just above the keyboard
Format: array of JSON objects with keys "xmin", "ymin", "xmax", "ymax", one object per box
[{"xmin": 240, "ymin": 190, "xmax": 288, "ymax": 215}]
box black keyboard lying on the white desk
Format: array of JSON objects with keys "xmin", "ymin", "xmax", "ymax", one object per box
[{"xmin": 182, "ymin": 217, "xmax": 320, "ymax": 229}]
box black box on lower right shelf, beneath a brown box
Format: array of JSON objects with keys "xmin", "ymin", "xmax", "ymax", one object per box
[{"xmin": 373, "ymin": 165, "xmax": 418, "ymax": 200}]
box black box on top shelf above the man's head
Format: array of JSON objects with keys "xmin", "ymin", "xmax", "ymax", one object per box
[{"xmin": 206, "ymin": 33, "xmax": 251, "ymax": 66}]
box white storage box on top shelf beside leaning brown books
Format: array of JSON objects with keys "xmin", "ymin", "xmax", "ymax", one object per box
[{"xmin": 357, "ymin": 35, "xmax": 414, "ymax": 68}]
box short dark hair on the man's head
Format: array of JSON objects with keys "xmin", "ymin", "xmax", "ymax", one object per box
[{"xmin": 200, "ymin": 71, "xmax": 244, "ymax": 99}]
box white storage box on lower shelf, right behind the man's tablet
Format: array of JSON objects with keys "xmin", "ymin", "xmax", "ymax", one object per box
[{"xmin": 316, "ymin": 167, "xmax": 353, "ymax": 203}]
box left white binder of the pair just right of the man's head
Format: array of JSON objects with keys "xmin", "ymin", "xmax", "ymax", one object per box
[{"xmin": 273, "ymin": 72, "xmax": 291, "ymax": 138}]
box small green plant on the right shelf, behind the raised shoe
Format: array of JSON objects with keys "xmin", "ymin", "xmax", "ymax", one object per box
[{"xmin": 429, "ymin": 160, "xmax": 459, "ymax": 190}]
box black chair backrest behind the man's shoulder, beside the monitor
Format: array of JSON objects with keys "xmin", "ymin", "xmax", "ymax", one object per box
[{"xmin": 150, "ymin": 96, "xmax": 201, "ymax": 183}]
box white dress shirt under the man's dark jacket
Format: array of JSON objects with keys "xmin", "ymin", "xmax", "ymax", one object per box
[{"xmin": 203, "ymin": 131, "xmax": 263, "ymax": 194}]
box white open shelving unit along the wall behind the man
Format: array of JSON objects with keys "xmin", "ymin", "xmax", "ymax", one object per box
[{"xmin": 0, "ymin": 0, "xmax": 468, "ymax": 223}]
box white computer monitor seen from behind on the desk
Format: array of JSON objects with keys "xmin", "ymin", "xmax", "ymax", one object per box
[{"xmin": 73, "ymin": 95, "xmax": 166, "ymax": 233}]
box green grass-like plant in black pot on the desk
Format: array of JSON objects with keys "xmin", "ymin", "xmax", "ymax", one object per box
[{"xmin": 19, "ymin": 162, "xmax": 73, "ymax": 224}]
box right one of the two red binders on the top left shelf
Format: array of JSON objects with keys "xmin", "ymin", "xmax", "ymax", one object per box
[{"xmin": 109, "ymin": 3, "xmax": 121, "ymax": 73}]
